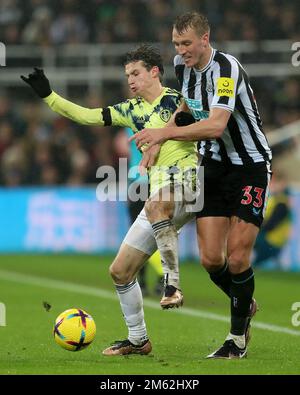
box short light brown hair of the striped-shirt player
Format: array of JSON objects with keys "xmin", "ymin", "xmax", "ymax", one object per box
[{"xmin": 173, "ymin": 11, "xmax": 210, "ymax": 36}]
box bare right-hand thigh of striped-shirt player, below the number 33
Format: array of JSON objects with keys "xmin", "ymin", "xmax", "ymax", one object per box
[{"xmin": 227, "ymin": 216, "xmax": 259, "ymax": 273}]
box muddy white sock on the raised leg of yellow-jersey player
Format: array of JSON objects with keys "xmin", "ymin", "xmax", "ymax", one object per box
[{"xmin": 152, "ymin": 219, "xmax": 180, "ymax": 288}]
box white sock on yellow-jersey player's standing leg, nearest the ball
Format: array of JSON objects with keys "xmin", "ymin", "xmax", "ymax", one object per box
[{"xmin": 115, "ymin": 280, "xmax": 148, "ymax": 345}]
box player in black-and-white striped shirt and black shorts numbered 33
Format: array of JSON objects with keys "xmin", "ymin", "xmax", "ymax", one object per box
[{"xmin": 134, "ymin": 12, "xmax": 272, "ymax": 359}]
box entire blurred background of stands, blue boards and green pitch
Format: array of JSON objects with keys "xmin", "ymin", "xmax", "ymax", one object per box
[{"xmin": 0, "ymin": 0, "xmax": 300, "ymax": 374}]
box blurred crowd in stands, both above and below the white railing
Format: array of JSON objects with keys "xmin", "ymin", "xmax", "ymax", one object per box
[{"xmin": 0, "ymin": 0, "xmax": 300, "ymax": 187}]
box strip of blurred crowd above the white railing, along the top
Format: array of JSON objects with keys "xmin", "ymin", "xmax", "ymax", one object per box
[{"xmin": 0, "ymin": 0, "xmax": 300, "ymax": 46}]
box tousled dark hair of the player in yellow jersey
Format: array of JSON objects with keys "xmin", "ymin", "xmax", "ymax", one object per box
[{"xmin": 124, "ymin": 44, "xmax": 164, "ymax": 80}]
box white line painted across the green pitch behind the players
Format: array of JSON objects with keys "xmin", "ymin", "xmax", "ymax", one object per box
[{"xmin": 0, "ymin": 270, "xmax": 300, "ymax": 336}]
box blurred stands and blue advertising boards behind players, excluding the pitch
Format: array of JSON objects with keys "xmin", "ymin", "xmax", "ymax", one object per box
[{"xmin": 0, "ymin": 0, "xmax": 300, "ymax": 270}]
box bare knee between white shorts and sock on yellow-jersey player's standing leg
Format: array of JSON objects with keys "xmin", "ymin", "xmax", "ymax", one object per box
[{"xmin": 110, "ymin": 242, "xmax": 149, "ymax": 284}]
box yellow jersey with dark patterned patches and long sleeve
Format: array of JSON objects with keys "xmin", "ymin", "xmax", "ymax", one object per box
[{"xmin": 44, "ymin": 88, "xmax": 197, "ymax": 193}]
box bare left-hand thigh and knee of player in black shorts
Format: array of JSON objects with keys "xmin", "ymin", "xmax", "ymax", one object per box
[{"xmin": 197, "ymin": 217, "xmax": 230, "ymax": 270}]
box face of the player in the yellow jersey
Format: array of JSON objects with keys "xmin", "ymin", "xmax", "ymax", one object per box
[{"xmin": 125, "ymin": 60, "xmax": 153, "ymax": 96}]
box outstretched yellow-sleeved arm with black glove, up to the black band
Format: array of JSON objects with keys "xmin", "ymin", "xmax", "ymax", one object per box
[{"xmin": 21, "ymin": 67, "xmax": 105, "ymax": 126}]
